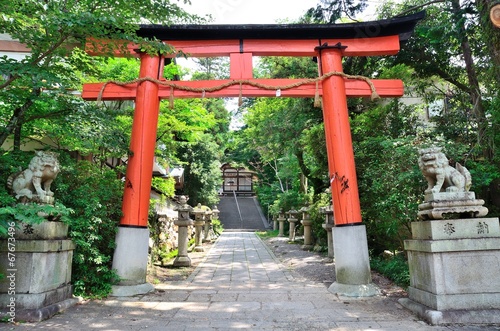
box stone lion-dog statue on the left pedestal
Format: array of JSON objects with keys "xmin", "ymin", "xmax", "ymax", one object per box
[{"xmin": 7, "ymin": 151, "xmax": 60, "ymax": 203}]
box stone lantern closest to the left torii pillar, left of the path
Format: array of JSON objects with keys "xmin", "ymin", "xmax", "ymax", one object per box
[{"xmin": 173, "ymin": 196, "xmax": 193, "ymax": 267}]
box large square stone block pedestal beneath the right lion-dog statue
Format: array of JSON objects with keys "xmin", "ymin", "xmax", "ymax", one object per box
[{"xmin": 399, "ymin": 218, "xmax": 500, "ymax": 325}]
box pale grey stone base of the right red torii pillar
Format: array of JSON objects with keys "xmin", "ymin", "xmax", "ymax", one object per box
[{"xmin": 328, "ymin": 225, "xmax": 379, "ymax": 297}]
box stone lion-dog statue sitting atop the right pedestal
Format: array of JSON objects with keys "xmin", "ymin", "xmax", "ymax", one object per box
[{"xmin": 418, "ymin": 147, "xmax": 472, "ymax": 193}]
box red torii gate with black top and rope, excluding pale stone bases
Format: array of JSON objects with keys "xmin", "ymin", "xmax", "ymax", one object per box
[{"xmin": 82, "ymin": 12, "xmax": 424, "ymax": 296}]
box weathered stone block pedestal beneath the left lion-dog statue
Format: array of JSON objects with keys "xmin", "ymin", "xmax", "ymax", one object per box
[{"xmin": 0, "ymin": 221, "xmax": 78, "ymax": 322}]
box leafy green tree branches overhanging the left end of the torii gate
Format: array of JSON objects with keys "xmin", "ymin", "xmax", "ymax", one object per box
[{"xmin": 0, "ymin": 0, "xmax": 203, "ymax": 148}]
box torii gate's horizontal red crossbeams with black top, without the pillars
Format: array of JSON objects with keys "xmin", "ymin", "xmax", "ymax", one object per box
[{"xmin": 83, "ymin": 12, "xmax": 424, "ymax": 100}]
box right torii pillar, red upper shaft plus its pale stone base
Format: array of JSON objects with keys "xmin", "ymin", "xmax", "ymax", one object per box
[{"xmin": 316, "ymin": 43, "xmax": 378, "ymax": 296}]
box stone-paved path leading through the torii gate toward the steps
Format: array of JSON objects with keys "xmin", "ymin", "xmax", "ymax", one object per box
[{"xmin": 0, "ymin": 232, "xmax": 500, "ymax": 331}]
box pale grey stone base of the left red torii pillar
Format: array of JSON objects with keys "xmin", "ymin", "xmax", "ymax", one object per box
[{"xmin": 111, "ymin": 227, "xmax": 154, "ymax": 297}]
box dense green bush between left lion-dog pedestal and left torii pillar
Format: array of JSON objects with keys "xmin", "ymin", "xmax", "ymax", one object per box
[{"xmin": 55, "ymin": 155, "xmax": 123, "ymax": 298}]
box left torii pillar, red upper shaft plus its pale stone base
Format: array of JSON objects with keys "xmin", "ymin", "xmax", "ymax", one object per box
[{"xmin": 108, "ymin": 53, "xmax": 162, "ymax": 296}]
